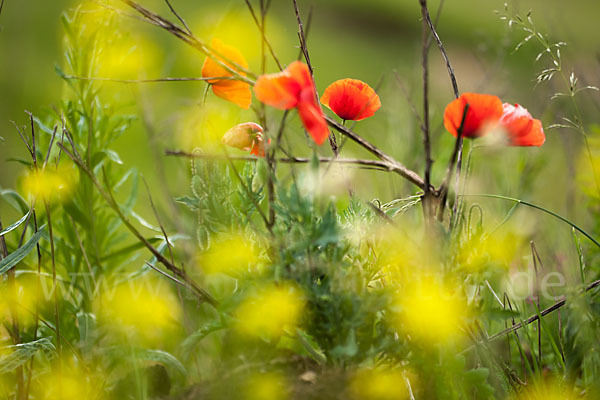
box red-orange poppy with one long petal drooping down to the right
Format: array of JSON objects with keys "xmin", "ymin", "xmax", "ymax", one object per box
[{"xmin": 254, "ymin": 61, "xmax": 329, "ymax": 145}]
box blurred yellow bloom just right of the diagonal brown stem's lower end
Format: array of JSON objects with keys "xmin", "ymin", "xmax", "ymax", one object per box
[{"xmin": 235, "ymin": 284, "xmax": 304, "ymax": 339}]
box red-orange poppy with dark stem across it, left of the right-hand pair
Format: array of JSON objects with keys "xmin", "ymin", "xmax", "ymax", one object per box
[{"xmin": 444, "ymin": 93, "xmax": 502, "ymax": 138}]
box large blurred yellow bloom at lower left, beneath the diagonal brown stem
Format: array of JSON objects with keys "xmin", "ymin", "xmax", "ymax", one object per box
[{"xmin": 95, "ymin": 279, "xmax": 181, "ymax": 344}]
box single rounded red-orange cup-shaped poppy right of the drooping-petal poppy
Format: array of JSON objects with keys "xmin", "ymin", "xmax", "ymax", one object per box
[{"xmin": 321, "ymin": 79, "xmax": 381, "ymax": 121}]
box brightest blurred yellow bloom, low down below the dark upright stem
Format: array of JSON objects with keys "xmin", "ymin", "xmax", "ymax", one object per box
[{"xmin": 395, "ymin": 277, "xmax": 467, "ymax": 343}]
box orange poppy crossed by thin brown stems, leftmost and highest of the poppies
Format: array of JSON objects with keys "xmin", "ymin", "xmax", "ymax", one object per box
[{"xmin": 202, "ymin": 39, "xmax": 252, "ymax": 109}]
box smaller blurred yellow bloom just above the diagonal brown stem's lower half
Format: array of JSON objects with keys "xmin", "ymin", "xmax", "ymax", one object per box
[{"xmin": 198, "ymin": 233, "xmax": 260, "ymax": 277}]
